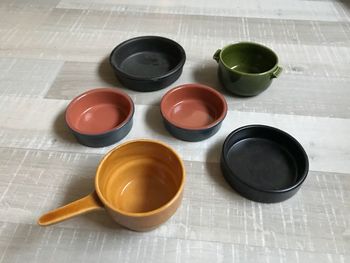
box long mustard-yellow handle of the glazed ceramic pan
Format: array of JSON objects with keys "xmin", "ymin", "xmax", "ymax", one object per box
[{"xmin": 38, "ymin": 191, "xmax": 104, "ymax": 226}]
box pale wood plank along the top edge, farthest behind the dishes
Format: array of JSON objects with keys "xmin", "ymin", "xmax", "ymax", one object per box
[{"xmin": 58, "ymin": 0, "xmax": 342, "ymax": 21}]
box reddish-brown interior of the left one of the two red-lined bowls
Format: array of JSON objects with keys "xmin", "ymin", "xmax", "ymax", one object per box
[{"xmin": 66, "ymin": 88, "xmax": 134, "ymax": 135}]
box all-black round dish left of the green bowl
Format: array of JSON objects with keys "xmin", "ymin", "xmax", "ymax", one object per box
[{"xmin": 110, "ymin": 36, "xmax": 186, "ymax": 91}]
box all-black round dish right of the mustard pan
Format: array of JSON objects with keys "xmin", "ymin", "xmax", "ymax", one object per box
[{"xmin": 221, "ymin": 125, "xmax": 309, "ymax": 203}]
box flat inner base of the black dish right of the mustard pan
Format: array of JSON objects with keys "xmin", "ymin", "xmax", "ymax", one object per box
[{"xmin": 227, "ymin": 138, "xmax": 298, "ymax": 190}]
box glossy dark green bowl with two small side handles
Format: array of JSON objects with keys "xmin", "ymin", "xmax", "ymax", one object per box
[{"xmin": 213, "ymin": 42, "xmax": 282, "ymax": 96}]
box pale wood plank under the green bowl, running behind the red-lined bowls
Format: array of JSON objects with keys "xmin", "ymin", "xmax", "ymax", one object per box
[{"xmin": 46, "ymin": 59, "xmax": 350, "ymax": 118}]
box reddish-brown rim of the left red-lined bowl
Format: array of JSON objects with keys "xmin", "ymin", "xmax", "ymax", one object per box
[{"xmin": 65, "ymin": 88, "xmax": 135, "ymax": 136}]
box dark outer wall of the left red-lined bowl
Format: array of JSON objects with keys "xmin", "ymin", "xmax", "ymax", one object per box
[{"xmin": 71, "ymin": 117, "xmax": 133, "ymax": 148}]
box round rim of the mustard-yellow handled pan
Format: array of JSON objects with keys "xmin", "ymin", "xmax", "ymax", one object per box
[{"xmin": 95, "ymin": 139, "xmax": 186, "ymax": 218}]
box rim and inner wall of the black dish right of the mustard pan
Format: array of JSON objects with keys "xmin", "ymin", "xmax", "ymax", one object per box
[{"xmin": 221, "ymin": 124, "xmax": 309, "ymax": 194}]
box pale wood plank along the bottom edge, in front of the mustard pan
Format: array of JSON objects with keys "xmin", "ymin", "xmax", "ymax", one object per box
[{"xmin": 0, "ymin": 224, "xmax": 349, "ymax": 263}]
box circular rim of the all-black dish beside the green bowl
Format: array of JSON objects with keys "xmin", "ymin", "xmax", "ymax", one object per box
[{"xmin": 109, "ymin": 35, "xmax": 186, "ymax": 81}]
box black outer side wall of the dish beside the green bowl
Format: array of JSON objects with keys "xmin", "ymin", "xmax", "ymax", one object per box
[{"xmin": 113, "ymin": 67, "xmax": 186, "ymax": 92}]
